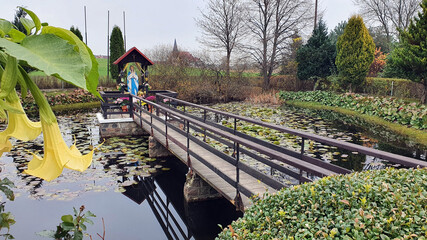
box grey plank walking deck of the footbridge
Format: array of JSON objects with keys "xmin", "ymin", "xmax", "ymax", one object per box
[{"xmin": 134, "ymin": 114, "xmax": 276, "ymax": 208}]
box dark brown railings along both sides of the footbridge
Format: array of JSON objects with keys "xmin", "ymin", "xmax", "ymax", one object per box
[{"xmin": 133, "ymin": 94, "xmax": 427, "ymax": 205}]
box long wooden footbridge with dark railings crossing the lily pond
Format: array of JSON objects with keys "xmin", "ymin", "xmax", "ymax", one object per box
[{"xmin": 102, "ymin": 91, "xmax": 427, "ymax": 210}]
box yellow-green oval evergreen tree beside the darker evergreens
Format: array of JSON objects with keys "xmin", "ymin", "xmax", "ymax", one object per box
[{"xmin": 335, "ymin": 16, "xmax": 375, "ymax": 92}]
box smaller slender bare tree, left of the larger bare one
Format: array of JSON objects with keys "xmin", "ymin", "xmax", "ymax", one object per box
[{"xmin": 196, "ymin": 0, "xmax": 244, "ymax": 76}]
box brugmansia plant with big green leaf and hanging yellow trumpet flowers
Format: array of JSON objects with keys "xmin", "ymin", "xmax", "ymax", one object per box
[{"xmin": 0, "ymin": 8, "xmax": 100, "ymax": 181}]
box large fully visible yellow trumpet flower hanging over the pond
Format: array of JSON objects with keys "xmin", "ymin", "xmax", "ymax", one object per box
[{"xmin": 24, "ymin": 118, "xmax": 99, "ymax": 181}]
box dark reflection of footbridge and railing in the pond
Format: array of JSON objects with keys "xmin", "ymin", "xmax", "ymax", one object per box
[{"xmin": 122, "ymin": 158, "xmax": 241, "ymax": 240}]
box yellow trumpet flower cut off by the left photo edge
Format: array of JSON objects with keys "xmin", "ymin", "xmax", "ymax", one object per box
[{"xmin": 0, "ymin": 101, "xmax": 42, "ymax": 156}]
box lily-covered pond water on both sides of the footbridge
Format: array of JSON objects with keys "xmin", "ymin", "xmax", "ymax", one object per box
[{"xmin": 0, "ymin": 103, "xmax": 425, "ymax": 239}]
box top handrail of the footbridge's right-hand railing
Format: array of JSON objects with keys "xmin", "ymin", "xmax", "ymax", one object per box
[{"xmin": 156, "ymin": 93, "xmax": 427, "ymax": 167}]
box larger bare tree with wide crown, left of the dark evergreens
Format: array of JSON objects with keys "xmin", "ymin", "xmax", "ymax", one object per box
[{"xmin": 247, "ymin": 0, "xmax": 313, "ymax": 89}]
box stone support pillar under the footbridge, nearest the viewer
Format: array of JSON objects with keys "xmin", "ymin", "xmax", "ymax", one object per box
[{"xmin": 184, "ymin": 173, "xmax": 222, "ymax": 202}]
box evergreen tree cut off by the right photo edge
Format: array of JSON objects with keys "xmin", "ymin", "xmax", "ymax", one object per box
[{"xmin": 385, "ymin": 0, "xmax": 427, "ymax": 103}]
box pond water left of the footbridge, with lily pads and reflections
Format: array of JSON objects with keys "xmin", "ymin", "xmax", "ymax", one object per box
[{"xmin": 0, "ymin": 114, "xmax": 241, "ymax": 239}]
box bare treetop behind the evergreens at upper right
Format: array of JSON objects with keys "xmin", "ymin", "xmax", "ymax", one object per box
[{"xmin": 353, "ymin": 0, "xmax": 421, "ymax": 39}]
